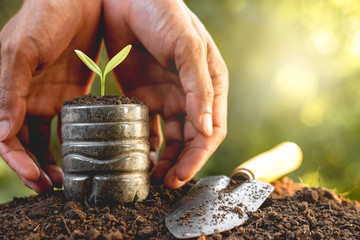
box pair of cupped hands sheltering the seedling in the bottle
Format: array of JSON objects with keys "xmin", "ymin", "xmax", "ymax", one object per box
[{"xmin": 0, "ymin": 0, "xmax": 228, "ymax": 193}]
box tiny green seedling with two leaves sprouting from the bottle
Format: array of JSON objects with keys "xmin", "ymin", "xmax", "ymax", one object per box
[{"xmin": 75, "ymin": 45, "xmax": 131, "ymax": 96}]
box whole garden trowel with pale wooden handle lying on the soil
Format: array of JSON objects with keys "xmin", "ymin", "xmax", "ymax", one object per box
[{"xmin": 165, "ymin": 142, "xmax": 302, "ymax": 239}]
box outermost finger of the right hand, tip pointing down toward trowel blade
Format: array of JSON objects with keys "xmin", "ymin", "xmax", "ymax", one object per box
[{"xmin": 164, "ymin": 41, "xmax": 228, "ymax": 188}]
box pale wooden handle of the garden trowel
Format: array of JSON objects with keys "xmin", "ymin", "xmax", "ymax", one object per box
[{"xmin": 231, "ymin": 142, "xmax": 302, "ymax": 183}]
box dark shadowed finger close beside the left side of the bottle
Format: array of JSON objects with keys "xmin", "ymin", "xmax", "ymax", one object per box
[{"xmin": 27, "ymin": 116, "xmax": 64, "ymax": 187}]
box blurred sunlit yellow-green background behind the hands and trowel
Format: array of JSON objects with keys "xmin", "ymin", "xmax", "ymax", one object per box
[{"xmin": 0, "ymin": 0, "xmax": 360, "ymax": 202}]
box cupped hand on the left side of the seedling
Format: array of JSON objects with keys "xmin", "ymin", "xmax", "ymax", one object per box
[{"xmin": 0, "ymin": 0, "xmax": 102, "ymax": 193}]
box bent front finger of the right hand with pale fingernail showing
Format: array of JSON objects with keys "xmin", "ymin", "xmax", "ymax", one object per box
[{"xmin": 175, "ymin": 30, "xmax": 214, "ymax": 136}]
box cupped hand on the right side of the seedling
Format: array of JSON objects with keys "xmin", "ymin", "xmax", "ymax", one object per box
[{"xmin": 104, "ymin": 0, "xmax": 228, "ymax": 188}]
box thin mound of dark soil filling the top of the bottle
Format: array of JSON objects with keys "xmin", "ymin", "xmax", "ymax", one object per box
[{"xmin": 63, "ymin": 93, "xmax": 144, "ymax": 106}]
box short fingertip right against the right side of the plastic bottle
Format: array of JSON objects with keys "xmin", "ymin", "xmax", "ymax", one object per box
[{"xmin": 149, "ymin": 113, "xmax": 163, "ymax": 165}]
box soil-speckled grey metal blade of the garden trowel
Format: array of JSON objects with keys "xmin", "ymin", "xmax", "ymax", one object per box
[{"xmin": 165, "ymin": 176, "xmax": 274, "ymax": 239}]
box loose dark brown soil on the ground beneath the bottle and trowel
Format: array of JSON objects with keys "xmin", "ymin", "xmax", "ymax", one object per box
[{"xmin": 0, "ymin": 178, "xmax": 360, "ymax": 240}]
